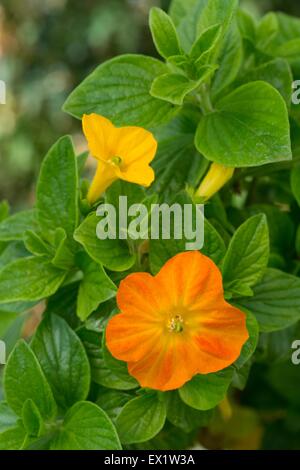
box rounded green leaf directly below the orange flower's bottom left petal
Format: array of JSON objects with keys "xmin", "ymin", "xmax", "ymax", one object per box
[{"xmin": 116, "ymin": 393, "xmax": 166, "ymax": 444}]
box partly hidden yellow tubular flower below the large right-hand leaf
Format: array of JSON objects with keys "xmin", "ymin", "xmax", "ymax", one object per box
[{"xmin": 196, "ymin": 163, "xmax": 235, "ymax": 200}]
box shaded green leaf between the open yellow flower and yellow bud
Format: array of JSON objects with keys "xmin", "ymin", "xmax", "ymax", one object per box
[{"xmin": 151, "ymin": 109, "xmax": 208, "ymax": 199}]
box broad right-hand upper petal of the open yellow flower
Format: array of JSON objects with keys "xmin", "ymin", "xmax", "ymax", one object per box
[{"xmin": 114, "ymin": 126, "xmax": 157, "ymax": 166}]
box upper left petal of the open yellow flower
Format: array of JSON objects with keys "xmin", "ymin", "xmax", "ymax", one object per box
[{"xmin": 82, "ymin": 113, "xmax": 116, "ymax": 160}]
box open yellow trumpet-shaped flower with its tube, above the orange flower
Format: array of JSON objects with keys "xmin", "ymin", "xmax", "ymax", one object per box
[{"xmin": 82, "ymin": 114, "xmax": 157, "ymax": 203}]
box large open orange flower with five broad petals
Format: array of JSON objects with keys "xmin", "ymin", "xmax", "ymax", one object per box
[{"xmin": 106, "ymin": 251, "xmax": 249, "ymax": 391}]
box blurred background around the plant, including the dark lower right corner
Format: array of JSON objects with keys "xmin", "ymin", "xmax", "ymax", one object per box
[{"xmin": 0, "ymin": 0, "xmax": 300, "ymax": 449}]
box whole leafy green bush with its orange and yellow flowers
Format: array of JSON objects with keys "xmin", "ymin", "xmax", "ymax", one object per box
[{"xmin": 0, "ymin": 0, "xmax": 300, "ymax": 450}]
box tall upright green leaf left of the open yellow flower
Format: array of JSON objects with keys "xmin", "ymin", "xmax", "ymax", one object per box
[{"xmin": 37, "ymin": 137, "xmax": 78, "ymax": 239}]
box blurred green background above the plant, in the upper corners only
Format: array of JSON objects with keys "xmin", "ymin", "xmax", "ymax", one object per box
[{"xmin": 0, "ymin": 0, "xmax": 300, "ymax": 208}]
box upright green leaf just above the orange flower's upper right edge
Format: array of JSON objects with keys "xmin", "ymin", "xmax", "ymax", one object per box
[{"xmin": 223, "ymin": 214, "xmax": 269, "ymax": 296}]
